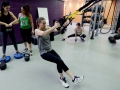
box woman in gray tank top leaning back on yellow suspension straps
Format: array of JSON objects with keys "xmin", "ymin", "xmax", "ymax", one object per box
[{"xmin": 35, "ymin": 17, "xmax": 84, "ymax": 88}]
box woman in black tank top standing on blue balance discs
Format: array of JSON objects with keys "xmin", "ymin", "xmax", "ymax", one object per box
[{"xmin": 0, "ymin": 1, "xmax": 19, "ymax": 59}]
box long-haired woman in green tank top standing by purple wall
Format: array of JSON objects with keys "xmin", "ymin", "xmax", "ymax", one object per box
[{"xmin": 18, "ymin": 4, "xmax": 34, "ymax": 56}]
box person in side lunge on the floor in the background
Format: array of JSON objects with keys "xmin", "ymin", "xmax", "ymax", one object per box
[{"xmin": 62, "ymin": 23, "xmax": 86, "ymax": 41}]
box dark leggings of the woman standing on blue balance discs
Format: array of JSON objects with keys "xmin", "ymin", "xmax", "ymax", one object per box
[{"xmin": 1, "ymin": 31, "xmax": 18, "ymax": 54}]
